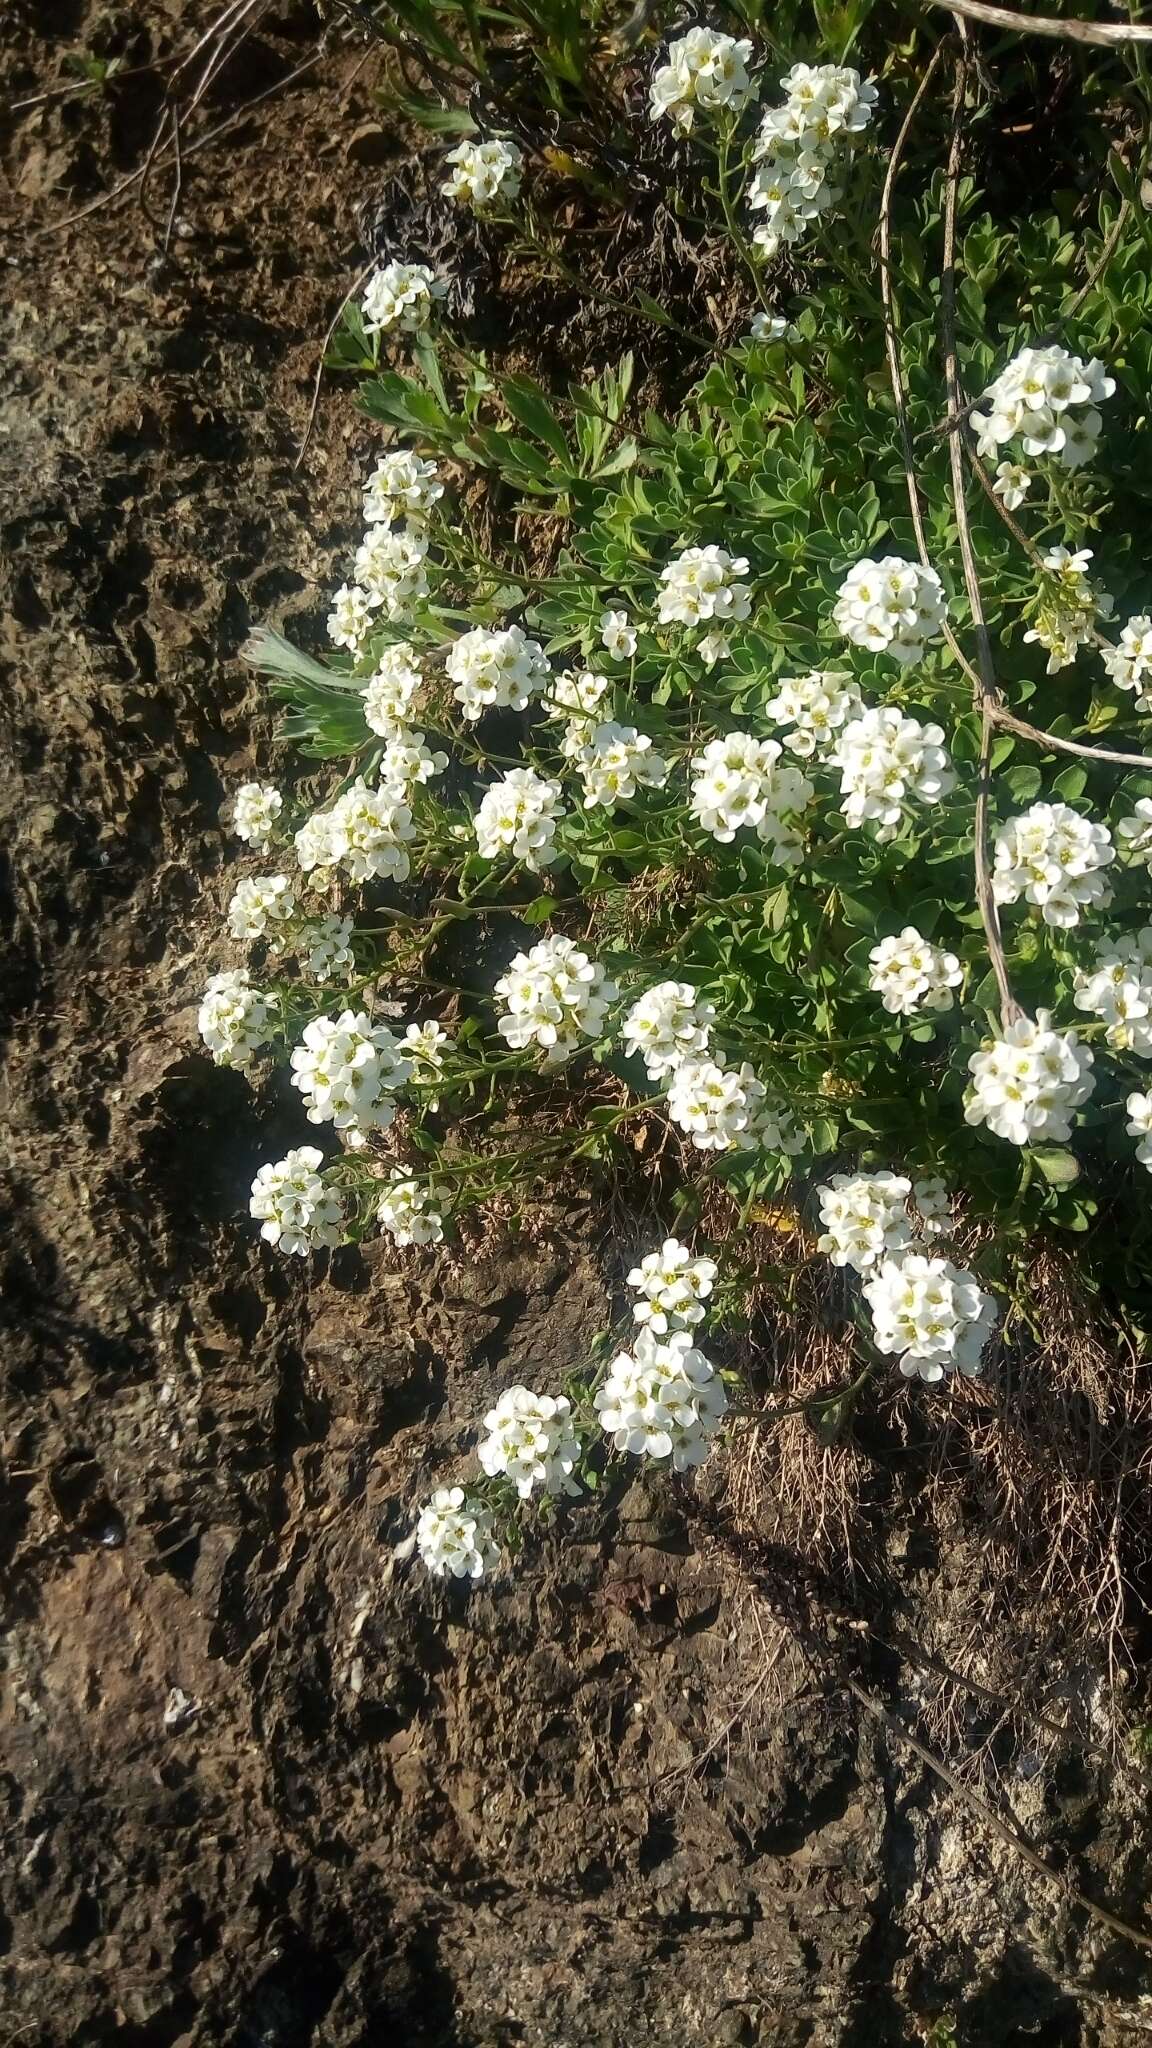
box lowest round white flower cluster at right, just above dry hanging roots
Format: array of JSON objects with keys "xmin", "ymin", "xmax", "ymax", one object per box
[{"xmin": 863, "ymin": 1251, "xmax": 996, "ymax": 1382}]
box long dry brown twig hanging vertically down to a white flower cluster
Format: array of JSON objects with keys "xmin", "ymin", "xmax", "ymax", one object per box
[{"xmin": 941, "ymin": 49, "xmax": 1023, "ymax": 1030}]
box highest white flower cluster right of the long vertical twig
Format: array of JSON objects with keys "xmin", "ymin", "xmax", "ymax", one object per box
[{"xmin": 972, "ymin": 342, "xmax": 1115, "ymax": 469}]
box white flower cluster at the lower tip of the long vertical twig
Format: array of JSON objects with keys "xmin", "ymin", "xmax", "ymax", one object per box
[{"xmin": 963, "ymin": 1010, "xmax": 1093, "ymax": 1145}]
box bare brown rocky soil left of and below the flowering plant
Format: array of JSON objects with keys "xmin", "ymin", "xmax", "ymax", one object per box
[{"xmin": 0, "ymin": 0, "xmax": 1152, "ymax": 2048}]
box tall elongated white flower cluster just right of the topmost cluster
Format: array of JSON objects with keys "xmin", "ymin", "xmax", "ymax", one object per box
[{"xmin": 748, "ymin": 63, "xmax": 877, "ymax": 258}]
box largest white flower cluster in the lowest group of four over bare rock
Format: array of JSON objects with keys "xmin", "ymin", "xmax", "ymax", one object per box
[{"xmin": 596, "ymin": 1329, "xmax": 728, "ymax": 1473}]
